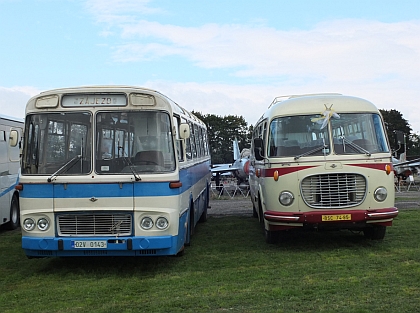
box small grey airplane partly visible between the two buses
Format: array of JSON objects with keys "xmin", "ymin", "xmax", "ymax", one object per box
[{"xmin": 211, "ymin": 138, "xmax": 251, "ymax": 186}]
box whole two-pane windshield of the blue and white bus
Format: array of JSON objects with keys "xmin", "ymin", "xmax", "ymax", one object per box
[{"xmin": 22, "ymin": 111, "xmax": 175, "ymax": 174}]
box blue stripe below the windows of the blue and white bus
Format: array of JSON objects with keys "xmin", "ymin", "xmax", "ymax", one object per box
[{"xmin": 20, "ymin": 162, "xmax": 210, "ymax": 199}]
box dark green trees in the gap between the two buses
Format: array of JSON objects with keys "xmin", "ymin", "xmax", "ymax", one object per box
[{"xmin": 192, "ymin": 112, "xmax": 250, "ymax": 164}]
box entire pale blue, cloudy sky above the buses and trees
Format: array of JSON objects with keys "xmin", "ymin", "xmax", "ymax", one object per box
[{"xmin": 0, "ymin": 0, "xmax": 420, "ymax": 133}]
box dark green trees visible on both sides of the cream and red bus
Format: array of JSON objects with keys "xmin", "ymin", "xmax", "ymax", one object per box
[{"xmin": 192, "ymin": 109, "xmax": 420, "ymax": 164}]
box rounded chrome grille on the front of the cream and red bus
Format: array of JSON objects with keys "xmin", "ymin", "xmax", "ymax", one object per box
[{"xmin": 301, "ymin": 173, "xmax": 366, "ymax": 208}]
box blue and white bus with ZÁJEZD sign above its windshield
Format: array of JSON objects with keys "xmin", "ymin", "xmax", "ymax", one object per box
[{"xmin": 18, "ymin": 86, "xmax": 211, "ymax": 257}]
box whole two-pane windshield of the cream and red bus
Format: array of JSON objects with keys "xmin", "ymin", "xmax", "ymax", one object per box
[{"xmin": 268, "ymin": 113, "xmax": 388, "ymax": 159}]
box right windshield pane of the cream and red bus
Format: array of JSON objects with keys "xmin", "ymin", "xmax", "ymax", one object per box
[{"xmin": 331, "ymin": 113, "xmax": 389, "ymax": 155}]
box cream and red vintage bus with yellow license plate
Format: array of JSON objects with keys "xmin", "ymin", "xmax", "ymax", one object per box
[{"xmin": 249, "ymin": 94, "xmax": 398, "ymax": 243}]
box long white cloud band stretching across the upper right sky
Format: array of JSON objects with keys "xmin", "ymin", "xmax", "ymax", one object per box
[{"xmin": 110, "ymin": 19, "xmax": 420, "ymax": 81}]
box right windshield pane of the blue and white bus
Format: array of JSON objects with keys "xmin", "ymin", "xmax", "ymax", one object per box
[{"xmin": 95, "ymin": 111, "xmax": 175, "ymax": 174}]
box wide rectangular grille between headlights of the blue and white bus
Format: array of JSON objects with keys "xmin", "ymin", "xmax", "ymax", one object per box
[{"xmin": 57, "ymin": 213, "xmax": 132, "ymax": 236}]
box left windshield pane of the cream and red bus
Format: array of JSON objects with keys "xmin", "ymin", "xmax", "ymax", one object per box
[{"xmin": 268, "ymin": 115, "xmax": 330, "ymax": 157}]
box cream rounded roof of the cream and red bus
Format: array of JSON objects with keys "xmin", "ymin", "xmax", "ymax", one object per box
[{"xmin": 257, "ymin": 93, "xmax": 378, "ymax": 123}]
